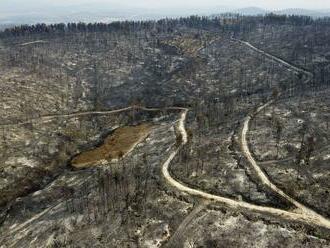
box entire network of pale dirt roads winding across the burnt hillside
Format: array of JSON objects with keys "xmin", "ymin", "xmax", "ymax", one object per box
[{"xmin": 0, "ymin": 36, "xmax": 330, "ymax": 242}]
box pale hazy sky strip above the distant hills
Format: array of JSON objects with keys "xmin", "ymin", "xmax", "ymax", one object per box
[{"xmin": 0, "ymin": 0, "xmax": 330, "ymax": 10}]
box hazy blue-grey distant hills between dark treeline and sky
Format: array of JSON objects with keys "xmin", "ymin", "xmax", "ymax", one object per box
[{"xmin": 0, "ymin": 3, "xmax": 330, "ymax": 26}]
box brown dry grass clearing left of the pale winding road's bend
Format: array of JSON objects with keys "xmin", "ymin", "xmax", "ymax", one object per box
[{"xmin": 71, "ymin": 124, "xmax": 152, "ymax": 169}]
